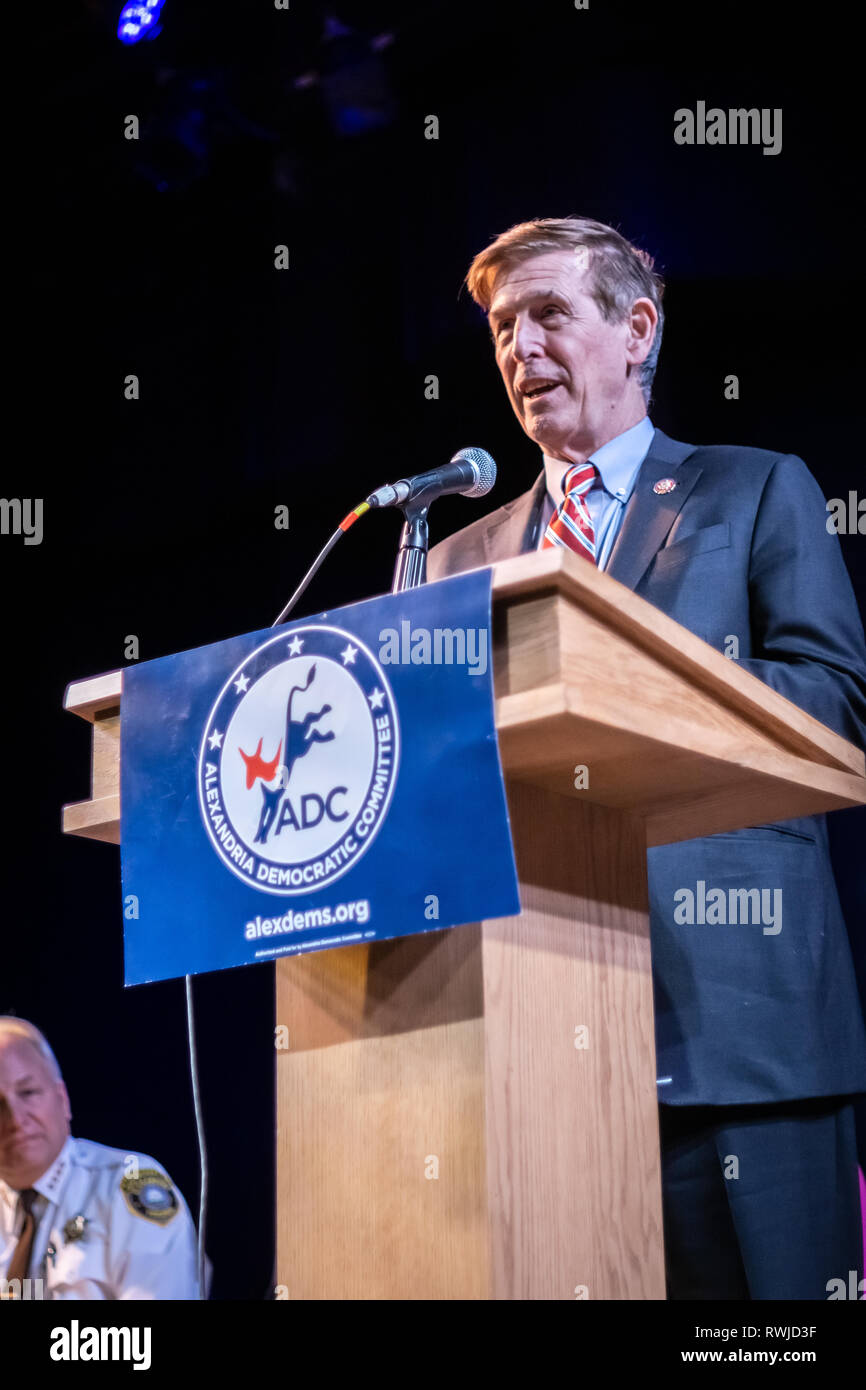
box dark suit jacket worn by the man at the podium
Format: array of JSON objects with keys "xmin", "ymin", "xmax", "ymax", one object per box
[{"xmin": 428, "ymin": 430, "xmax": 866, "ymax": 1105}]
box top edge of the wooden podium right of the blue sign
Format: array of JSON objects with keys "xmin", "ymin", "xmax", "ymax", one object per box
[{"xmin": 492, "ymin": 546, "xmax": 866, "ymax": 777}]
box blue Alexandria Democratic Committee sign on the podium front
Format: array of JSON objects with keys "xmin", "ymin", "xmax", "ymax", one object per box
[{"xmin": 121, "ymin": 570, "xmax": 520, "ymax": 984}]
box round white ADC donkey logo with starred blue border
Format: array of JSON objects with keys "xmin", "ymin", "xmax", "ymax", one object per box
[{"xmin": 197, "ymin": 624, "xmax": 399, "ymax": 894}]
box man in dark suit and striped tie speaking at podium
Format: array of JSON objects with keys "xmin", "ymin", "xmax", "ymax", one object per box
[{"xmin": 428, "ymin": 217, "xmax": 866, "ymax": 1300}]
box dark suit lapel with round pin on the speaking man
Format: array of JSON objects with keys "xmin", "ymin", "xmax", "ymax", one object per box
[{"xmin": 606, "ymin": 430, "xmax": 701, "ymax": 589}]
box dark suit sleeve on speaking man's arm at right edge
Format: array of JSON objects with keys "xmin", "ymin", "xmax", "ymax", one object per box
[{"xmin": 738, "ymin": 455, "xmax": 866, "ymax": 748}]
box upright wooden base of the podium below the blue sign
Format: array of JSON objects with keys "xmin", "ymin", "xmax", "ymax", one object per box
[{"xmin": 277, "ymin": 783, "xmax": 664, "ymax": 1300}]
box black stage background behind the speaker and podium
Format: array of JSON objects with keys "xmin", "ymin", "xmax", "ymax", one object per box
[{"xmin": 0, "ymin": 0, "xmax": 866, "ymax": 1298}]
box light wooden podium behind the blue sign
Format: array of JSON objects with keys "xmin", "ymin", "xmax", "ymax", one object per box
[{"xmin": 64, "ymin": 549, "xmax": 866, "ymax": 1300}]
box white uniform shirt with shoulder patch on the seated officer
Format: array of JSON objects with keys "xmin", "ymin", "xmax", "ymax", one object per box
[{"xmin": 0, "ymin": 1137, "xmax": 199, "ymax": 1300}]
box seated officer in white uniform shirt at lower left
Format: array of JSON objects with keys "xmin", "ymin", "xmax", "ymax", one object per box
[{"xmin": 0, "ymin": 1016, "xmax": 199, "ymax": 1298}]
